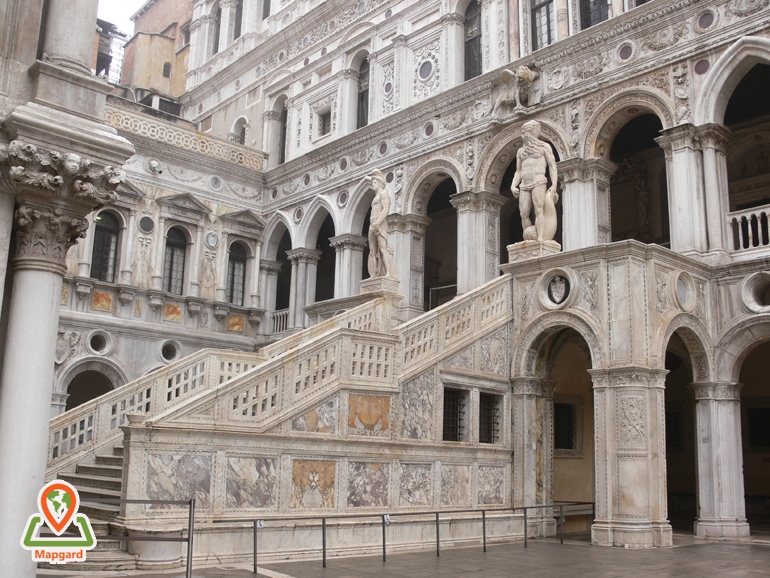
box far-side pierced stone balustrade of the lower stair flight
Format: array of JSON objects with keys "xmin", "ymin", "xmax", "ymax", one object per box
[{"xmin": 48, "ymin": 349, "xmax": 259, "ymax": 475}]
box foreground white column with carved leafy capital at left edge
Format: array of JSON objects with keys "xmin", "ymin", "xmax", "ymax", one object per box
[{"xmin": 0, "ymin": 141, "xmax": 125, "ymax": 578}]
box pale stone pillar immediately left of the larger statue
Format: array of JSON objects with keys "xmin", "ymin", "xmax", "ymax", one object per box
[{"xmin": 450, "ymin": 191, "xmax": 505, "ymax": 295}]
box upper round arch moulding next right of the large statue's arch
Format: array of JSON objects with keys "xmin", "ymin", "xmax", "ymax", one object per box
[{"xmin": 583, "ymin": 88, "xmax": 674, "ymax": 159}]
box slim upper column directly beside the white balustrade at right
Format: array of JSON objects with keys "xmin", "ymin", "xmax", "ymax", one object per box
[{"xmin": 697, "ymin": 124, "xmax": 733, "ymax": 253}]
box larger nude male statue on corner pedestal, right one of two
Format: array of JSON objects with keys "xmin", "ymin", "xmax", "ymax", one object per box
[{"xmin": 511, "ymin": 120, "xmax": 559, "ymax": 241}]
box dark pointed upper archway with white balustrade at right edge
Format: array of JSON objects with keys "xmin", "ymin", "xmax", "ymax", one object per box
[{"xmin": 725, "ymin": 64, "xmax": 770, "ymax": 249}]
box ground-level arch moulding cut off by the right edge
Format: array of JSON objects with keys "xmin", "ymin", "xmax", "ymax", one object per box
[{"xmin": 714, "ymin": 313, "xmax": 770, "ymax": 382}]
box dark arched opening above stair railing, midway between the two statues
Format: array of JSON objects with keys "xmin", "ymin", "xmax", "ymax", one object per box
[{"xmin": 423, "ymin": 178, "xmax": 457, "ymax": 311}]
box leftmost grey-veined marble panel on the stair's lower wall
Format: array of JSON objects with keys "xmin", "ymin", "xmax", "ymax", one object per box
[{"xmin": 146, "ymin": 453, "xmax": 213, "ymax": 509}]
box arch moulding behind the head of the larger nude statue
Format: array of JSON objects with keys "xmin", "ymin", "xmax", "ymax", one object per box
[{"xmin": 474, "ymin": 119, "xmax": 570, "ymax": 193}]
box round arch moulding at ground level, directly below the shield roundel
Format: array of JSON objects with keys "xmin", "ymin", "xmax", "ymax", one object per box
[{"xmin": 512, "ymin": 311, "xmax": 604, "ymax": 377}]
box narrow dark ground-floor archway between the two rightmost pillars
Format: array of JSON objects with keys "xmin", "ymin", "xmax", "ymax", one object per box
[{"xmin": 665, "ymin": 333, "xmax": 698, "ymax": 533}]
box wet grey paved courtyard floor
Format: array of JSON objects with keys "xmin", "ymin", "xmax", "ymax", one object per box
[{"xmin": 39, "ymin": 537, "xmax": 770, "ymax": 578}]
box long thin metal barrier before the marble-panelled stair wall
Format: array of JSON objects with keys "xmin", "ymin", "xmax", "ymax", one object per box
[{"xmin": 213, "ymin": 502, "xmax": 596, "ymax": 575}]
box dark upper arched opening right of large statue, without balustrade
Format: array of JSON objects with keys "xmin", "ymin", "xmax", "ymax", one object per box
[{"xmin": 610, "ymin": 114, "xmax": 671, "ymax": 247}]
